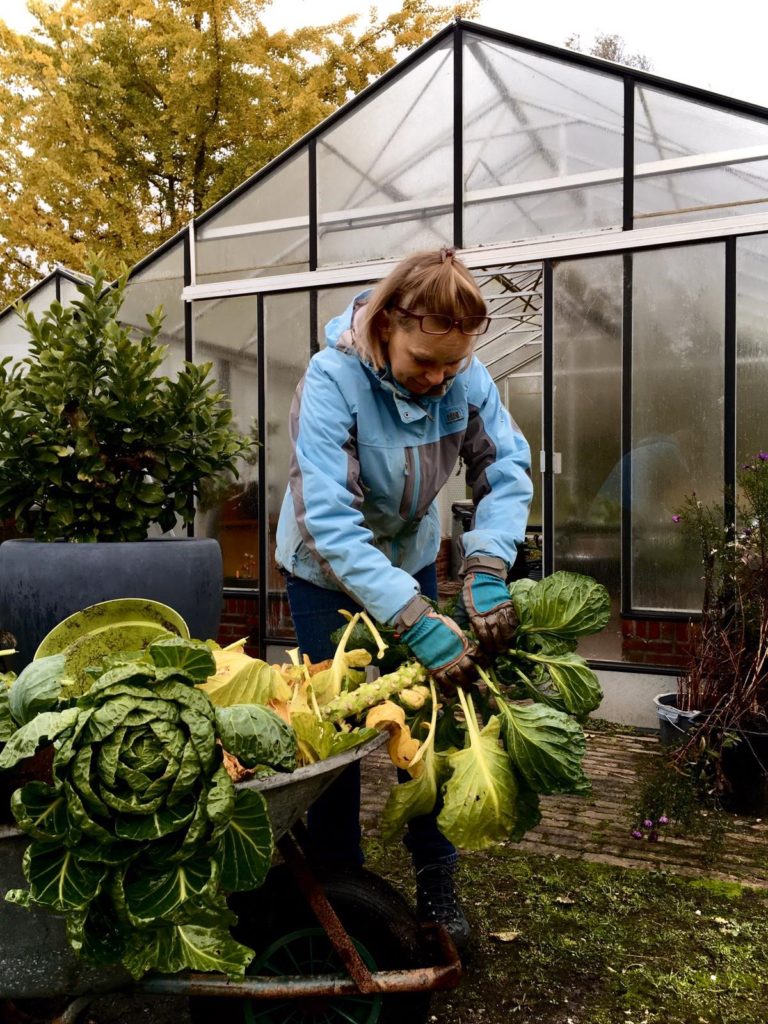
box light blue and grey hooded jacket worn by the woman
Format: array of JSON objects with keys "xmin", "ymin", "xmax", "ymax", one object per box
[{"xmin": 276, "ymin": 292, "xmax": 532, "ymax": 623}]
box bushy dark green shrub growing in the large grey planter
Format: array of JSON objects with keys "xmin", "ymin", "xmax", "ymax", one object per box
[{"xmin": 0, "ymin": 259, "xmax": 255, "ymax": 541}]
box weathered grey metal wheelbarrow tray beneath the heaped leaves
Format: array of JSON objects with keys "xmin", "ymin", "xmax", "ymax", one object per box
[{"xmin": 0, "ymin": 733, "xmax": 387, "ymax": 999}]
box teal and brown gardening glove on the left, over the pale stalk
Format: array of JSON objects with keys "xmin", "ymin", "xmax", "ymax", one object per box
[{"xmin": 395, "ymin": 596, "xmax": 477, "ymax": 696}]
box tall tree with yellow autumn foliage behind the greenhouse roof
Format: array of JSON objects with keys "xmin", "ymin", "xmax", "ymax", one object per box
[{"xmin": 0, "ymin": 0, "xmax": 476, "ymax": 308}]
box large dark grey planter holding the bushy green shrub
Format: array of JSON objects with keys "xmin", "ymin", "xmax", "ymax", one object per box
[{"xmin": 0, "ymin": 538, "xmax": 222, "ymax": 672}]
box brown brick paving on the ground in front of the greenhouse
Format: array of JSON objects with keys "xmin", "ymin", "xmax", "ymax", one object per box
[{"xmin": 361, "ymin": 732, "xmax": 768, "ymax": 888}]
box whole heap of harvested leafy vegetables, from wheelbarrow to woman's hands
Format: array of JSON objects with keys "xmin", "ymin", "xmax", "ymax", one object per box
[{"xmin": 0, "ymin": 572, "xmax": 609, "ymax": 977}]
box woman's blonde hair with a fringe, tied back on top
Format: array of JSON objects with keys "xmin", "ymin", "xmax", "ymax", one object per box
[{"xmin": 358, "ymin": 248, "xmax": 487, "ymax": 370}]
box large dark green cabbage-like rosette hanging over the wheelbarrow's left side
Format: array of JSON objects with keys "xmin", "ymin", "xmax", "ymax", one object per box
[{"xmin": 0, "ymin": 637, "xmax": 296, "ymax": 977}]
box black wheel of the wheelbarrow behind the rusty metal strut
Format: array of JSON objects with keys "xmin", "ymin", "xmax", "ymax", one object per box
[{"xmin": 189, "ymin": 867, "xmax": 430, "ymax": 1024}]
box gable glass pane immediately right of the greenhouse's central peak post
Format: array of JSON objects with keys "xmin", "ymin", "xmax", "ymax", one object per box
[{"xmin": 464, "ymin": 33, "xmax": 624, "ymax": 245}]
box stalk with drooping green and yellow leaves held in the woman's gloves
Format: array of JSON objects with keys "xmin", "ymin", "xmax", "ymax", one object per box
[{"xmin": 339, "ymin": 572, "xmax": 610, "ymax": 850}]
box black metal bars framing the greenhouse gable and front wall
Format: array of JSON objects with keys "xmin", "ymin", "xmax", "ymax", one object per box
[{"xmin": 105, "ymin": 19, "xmax": 768, "ymax": 673}]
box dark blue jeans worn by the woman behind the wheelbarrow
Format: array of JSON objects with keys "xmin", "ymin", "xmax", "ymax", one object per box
[{"xmin": 286, "ymin": 564, "xmax": 456, "ymax": 870}]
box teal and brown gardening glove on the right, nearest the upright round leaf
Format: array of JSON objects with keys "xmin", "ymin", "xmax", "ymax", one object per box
[{"xmin": 456, "ymin": 555, "xmax": 517, "ymax": 654}]
